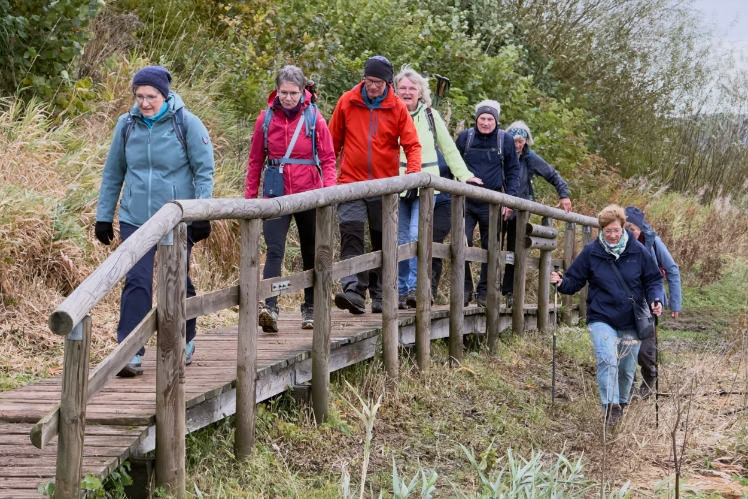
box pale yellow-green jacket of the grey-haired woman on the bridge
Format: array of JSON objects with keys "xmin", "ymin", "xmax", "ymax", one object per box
[{"xmin": 400, "ymin": 103, "xmax": 474, "ymax": 189}]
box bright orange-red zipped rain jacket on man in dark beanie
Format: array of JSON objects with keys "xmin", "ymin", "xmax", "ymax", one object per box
[{"xmin": 329, "ymin": 82, "xmax": 421, "ymax": 184}]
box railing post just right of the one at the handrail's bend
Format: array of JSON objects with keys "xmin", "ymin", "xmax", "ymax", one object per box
[{"xmin": 449, "ymin": 196, "xmax": 465, "ymax": 367}]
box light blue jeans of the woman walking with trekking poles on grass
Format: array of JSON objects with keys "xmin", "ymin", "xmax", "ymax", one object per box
[{"xmin": 588, "ymin": 322, "xmax": 641, "ymax": 409}]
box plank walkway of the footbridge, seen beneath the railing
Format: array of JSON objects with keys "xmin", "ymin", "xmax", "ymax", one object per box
[{"xmin": 0, "ymin": 305, "xmax": 553, "ymax": 499}]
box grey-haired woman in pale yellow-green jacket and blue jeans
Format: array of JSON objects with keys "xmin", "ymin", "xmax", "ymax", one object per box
[{"xmin": 395, "ymin": 65, "xmax": 483, "ymax": 309}]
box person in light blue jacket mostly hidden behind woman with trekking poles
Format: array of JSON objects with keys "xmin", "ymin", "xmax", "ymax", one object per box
[{"xmin": 625, "ymin": 206, "xmax": 683, "ymax": 399}]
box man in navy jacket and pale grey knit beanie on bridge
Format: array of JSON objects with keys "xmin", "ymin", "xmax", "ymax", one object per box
[{"xmin": 453, "ymin": 100, "xmax": 519, "ymax": 307}]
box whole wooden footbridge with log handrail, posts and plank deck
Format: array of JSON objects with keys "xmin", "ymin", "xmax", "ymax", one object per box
[{"xmin": 0, "ymin": 173, "xmax": 597, "ymax": 498}]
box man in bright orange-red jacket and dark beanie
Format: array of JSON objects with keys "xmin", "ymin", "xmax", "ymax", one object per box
[{"xmin": 329, "ymin": 56, "xmax": 421, "ymax": 314}]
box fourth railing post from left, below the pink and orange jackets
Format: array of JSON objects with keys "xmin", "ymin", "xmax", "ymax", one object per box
[{"xmin": 312, "ymin": 206, "xmax": 335, "ymax": 424}]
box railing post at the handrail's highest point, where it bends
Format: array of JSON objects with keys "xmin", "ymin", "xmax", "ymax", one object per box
[{"xmin": 416, "ymin": 187, "xmax": 434, "ymax": 373}]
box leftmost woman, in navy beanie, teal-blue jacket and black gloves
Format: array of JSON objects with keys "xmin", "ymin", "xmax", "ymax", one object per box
[{"xmin": 94, "ymin": 66, "xmax": 214, "ymax": 377}]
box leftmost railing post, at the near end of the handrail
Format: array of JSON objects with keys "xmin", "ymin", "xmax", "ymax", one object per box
[{"xmin": 54, "ymin": 316, "xmax": 91, "ymax": 499}]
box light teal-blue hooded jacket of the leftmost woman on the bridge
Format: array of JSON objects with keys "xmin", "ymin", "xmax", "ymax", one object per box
[{"xmin": 96, "ymin": 92, "xmax": 214, "ymax": 227}]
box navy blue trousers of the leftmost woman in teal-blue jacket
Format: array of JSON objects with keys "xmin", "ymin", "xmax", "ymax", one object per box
[{"xmin": 117, "ymin": 222, "xmax": 197, "ymax": 355}]
